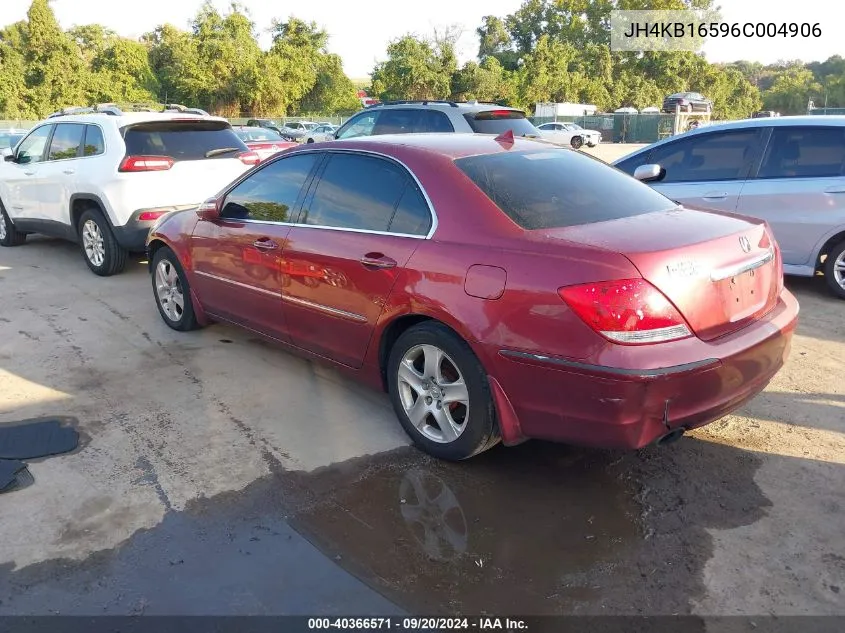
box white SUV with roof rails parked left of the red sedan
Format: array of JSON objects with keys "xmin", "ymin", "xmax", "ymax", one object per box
[{"xmin": 0, "ymin": 107, "xmax": 260, "ymax": 276}]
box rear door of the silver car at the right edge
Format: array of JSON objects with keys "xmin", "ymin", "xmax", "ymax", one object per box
[{"xmin": 737, "ymin": 125, "xmax": 845, "ymax": 266}]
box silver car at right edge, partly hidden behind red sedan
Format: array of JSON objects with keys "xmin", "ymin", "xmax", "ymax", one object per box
[{"xmin": 615, "ymin": 116, "xmax": 845, "ymax": 299}]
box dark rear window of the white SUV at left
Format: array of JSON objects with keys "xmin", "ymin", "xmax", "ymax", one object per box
[{"xmin": 123, "ymin": 120, "xmax": 249, "ymax": 161}]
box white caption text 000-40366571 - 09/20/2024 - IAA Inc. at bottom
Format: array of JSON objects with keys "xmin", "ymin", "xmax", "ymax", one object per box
[{"xmin": 308, "ymin": 617, "xmax": 528, "ymax": 632}]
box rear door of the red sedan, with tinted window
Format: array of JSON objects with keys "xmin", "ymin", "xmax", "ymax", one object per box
[{"xmin": 282, "ymin": 152, "xmax": 432, "ymax": 367}]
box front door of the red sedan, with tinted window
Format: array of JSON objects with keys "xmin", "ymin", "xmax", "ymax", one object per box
[{"xmin": 191, "ymin": 153, "xmax": 320, "ymax": 341}]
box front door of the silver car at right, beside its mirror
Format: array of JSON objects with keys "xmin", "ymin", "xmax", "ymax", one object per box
[{"xmin": 649, "ymin": 128, "xmax": 763, "ymax": 212}]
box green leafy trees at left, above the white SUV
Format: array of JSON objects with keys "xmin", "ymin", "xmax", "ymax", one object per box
[{"xmin": 0, "ymin": 0, "xmax": 360, "ymax": 119}]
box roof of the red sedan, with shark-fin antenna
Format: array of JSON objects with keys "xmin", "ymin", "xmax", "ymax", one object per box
[{"xmin": 301, "ymin": 132, "xmax": 570, "ymax": 159}]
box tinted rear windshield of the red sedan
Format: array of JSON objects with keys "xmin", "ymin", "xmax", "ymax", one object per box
[{"xmin": 455, "ymin": 149, "xmax": 677, "ymax": 230}]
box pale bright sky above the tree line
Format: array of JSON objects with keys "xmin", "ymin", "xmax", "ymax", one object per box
[{"xmin": 0, "ymin": 0, "xmax": 845, "ymax": 79}]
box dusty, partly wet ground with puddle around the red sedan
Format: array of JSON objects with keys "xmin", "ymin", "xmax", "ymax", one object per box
[{"xmin": 0, "ymin": 146, "xmax": 845, "ymax": 615}]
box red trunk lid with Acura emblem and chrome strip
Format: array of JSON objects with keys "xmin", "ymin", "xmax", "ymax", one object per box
[{"xmin": 545, "ymin": 208, "xmax": 782, "ymax": 341}]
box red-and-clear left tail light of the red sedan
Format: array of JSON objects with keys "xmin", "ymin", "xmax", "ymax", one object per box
[{"xmin": 558, "ymin": 279, "xmax": 692, "ymax": 345}]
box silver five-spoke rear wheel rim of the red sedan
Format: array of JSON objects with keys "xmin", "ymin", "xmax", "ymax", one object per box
[{"xmin": 398, "ymin": 345, "xmax": 469, "ymax": 444}]
